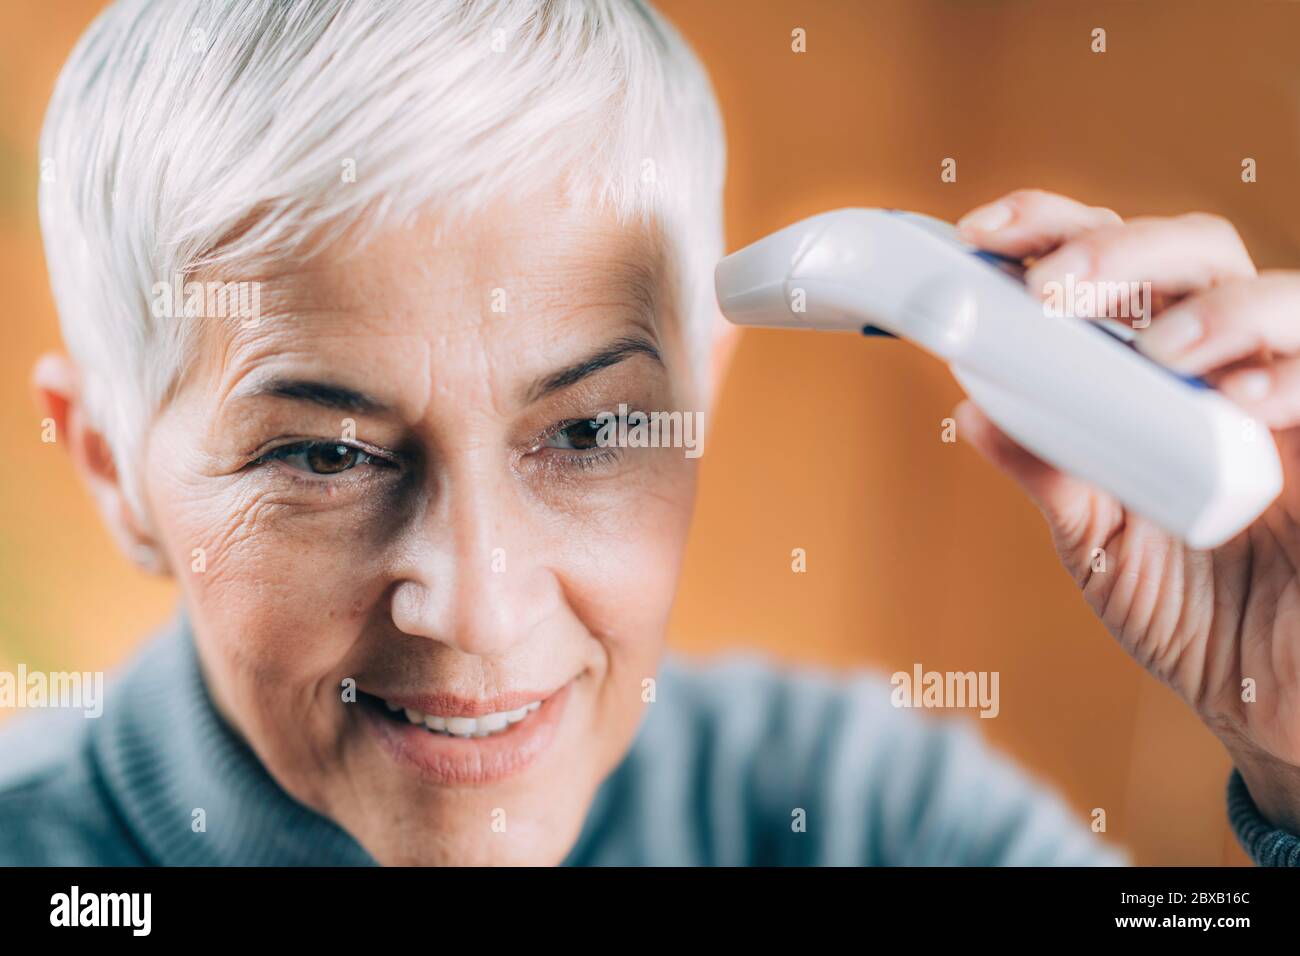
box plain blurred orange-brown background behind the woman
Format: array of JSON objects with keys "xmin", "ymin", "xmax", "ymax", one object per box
[{"xmin": 0, "ymin": 0, "xmax": 1300, "ymax": 865}]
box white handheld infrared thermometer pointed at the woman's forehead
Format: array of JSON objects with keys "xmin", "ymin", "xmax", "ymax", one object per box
[{"xmin": 715, "ymin": 208, "xmax": 1282, "ymax": 548}]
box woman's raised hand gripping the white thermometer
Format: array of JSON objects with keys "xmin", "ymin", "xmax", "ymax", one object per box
[{"xmin": 956, "ymin": 190, "xmax": 1300, "ymax": 832}]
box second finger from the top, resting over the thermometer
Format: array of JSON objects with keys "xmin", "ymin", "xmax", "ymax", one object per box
[{"xmin": 1024, "ymin": 212, "xmax": 1255, "ymax": 295}]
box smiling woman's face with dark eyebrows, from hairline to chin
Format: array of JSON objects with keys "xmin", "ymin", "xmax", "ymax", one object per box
[{"xmin": 146, "ymin": 196, "xmax": 694, "ymax": 864}]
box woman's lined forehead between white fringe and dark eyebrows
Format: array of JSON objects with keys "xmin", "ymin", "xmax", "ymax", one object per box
[{"xmin": 192, "ymin": 202, "xmax": 670, "ymax": 408}]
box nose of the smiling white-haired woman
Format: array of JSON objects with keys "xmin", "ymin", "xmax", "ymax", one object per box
[{"xmin": 391, "ymin": 463, "xmax": 560, "ymax": 658}]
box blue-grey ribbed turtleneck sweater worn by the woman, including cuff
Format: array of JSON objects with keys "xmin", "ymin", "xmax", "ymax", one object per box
[{"xmin": 0, "ymin": 619, "xmax": 1300, "ymax": 866}]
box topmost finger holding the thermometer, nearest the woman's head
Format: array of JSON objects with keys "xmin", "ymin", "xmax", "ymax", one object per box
[{"xmin": 957, "ymin": 189, "xmax": 1123, "ymax": 259}]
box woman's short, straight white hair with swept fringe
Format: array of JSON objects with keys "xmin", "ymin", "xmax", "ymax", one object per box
[{"xmin": 40, "ymin": 0, "xmax": 725, "ymax": 520}]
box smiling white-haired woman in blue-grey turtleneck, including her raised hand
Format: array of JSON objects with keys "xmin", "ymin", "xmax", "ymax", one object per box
[{"xmin": 0, "ymin": 0, "xmax": 1300, "ymax": 865}]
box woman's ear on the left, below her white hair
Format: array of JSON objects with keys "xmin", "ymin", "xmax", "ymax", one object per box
[{"xmin": 31, "ymin": 354, "xmax": 166, "ymax": 574}]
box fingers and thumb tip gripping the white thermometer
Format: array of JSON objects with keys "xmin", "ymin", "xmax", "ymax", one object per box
[{"xmin": 958, "ymin": 190, "xmax": 1300, "ymax": 442}]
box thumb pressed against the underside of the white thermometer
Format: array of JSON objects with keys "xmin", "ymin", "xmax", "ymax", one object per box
[{"xmin": 953, "ymin": 398, "xmax": 1097, "ymax": 545}]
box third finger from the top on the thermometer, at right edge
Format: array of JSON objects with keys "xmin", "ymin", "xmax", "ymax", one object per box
[{"xmin": 1138, "ymin": 272, "xmax": 1300, "ymax": 377}]
